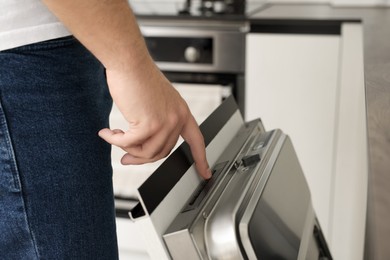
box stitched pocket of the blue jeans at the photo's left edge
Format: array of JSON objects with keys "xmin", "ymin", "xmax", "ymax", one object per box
[{"xmin": 0, "ymin": 100, "xmax": 21, "ymax": 193}]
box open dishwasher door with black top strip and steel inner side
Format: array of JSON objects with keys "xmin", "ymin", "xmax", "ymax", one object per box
[{"xmin": 126, "ymin": 97, "xmax": 332, "ymax": 260}]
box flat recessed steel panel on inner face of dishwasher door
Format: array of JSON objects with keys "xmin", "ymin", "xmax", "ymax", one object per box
[{"xmin": 239, "ymin": 137, "xmax": 312, "ymax": 259}]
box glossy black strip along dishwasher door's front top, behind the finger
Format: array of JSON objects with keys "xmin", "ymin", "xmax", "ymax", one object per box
[{"xmin": 138, "ymin": 96, "xmax": 238, "ymax": 214}]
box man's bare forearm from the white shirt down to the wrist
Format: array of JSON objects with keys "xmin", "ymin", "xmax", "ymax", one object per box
[{"xmin": 42, "ymin": 0, "xmax": 152, "ymax": 74}]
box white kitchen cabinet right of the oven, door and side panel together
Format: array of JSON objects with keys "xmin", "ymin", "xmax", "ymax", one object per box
[{"xmin": 245, "ymin": 23, "xmax": 368, "ymax": 259}]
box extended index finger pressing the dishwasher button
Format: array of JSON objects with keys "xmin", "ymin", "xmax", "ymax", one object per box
[{"xmin": 181, "ymin": 115, "xmax": 211, "ymax": 179}]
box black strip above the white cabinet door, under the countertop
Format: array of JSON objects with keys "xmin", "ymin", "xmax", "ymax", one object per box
[{"xmin": 250, "ymin": 19, "xmax": 360, "ymax": 35}]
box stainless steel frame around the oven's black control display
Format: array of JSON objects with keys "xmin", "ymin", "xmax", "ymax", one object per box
[{"xmin": 140, "ymin": 20, "xmax": 248, "ymax": 73}]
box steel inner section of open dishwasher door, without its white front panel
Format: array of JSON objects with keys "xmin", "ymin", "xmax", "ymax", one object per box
[{"xmin": 163, "ymin": 120, "xmax": 332, "ymax": 260}]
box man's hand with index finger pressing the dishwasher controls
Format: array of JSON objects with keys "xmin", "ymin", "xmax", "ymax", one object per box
[{"xmin": 99, "ymin": 62, "xmax": 211, "ymax": 179}]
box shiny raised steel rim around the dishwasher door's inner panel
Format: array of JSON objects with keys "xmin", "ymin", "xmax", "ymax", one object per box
[{"xmin": 205, "ymin": 131, "xmax": 285, "ymax": 259}]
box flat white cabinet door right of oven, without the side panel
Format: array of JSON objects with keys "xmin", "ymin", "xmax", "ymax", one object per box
[{"xmin": 245, "ymin": 34, "xmax": 340, "ymax": 244}]
